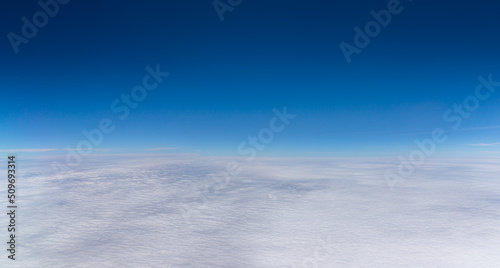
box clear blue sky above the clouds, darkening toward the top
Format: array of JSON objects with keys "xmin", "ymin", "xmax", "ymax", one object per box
[{"xmin": 0, "ymin": 0, "xmax": 500, "ymax": 155}]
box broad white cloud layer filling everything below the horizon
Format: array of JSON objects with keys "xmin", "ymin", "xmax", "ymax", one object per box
[{"xmin": 0, "ymin": 156, "xmax": 500, "ymax": 268}]
